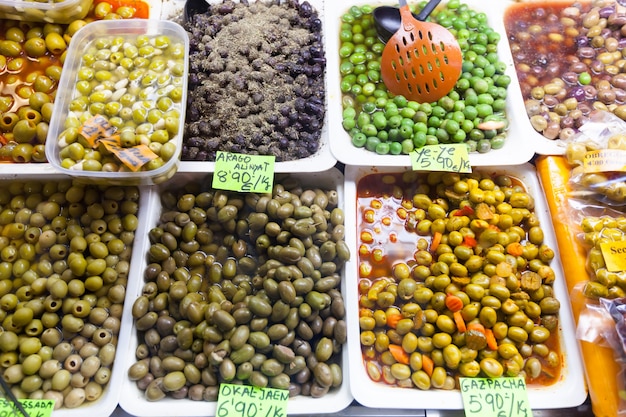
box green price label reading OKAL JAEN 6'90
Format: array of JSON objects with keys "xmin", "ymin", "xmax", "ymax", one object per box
[{"xmin": 215, "ymin": 384, "xmax": 289, "ymax": 417}]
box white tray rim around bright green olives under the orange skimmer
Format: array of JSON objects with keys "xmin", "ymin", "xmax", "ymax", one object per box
[{"xmin": 325, "ymin": 0, "xmax": 536, "ymax": 166}]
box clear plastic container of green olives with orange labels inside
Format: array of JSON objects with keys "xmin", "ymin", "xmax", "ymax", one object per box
[{"xmin": 46, "ymin": 19, "xmax": 189, "ymax": 185}]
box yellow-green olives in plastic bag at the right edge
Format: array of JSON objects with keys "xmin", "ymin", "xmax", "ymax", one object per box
[{"xmin": 581, "ymin": 216, "xmax": 626, "ymax": 300}]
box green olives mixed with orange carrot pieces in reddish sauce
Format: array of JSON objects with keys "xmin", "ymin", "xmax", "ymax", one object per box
[{"xmin": 357, "ymin": 171, "xmax": 561, "ymax": 390}]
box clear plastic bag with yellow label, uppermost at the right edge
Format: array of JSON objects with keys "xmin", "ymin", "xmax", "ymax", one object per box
[{"xmin": 564, "ymin": 110, "xmax": 626, "ymax": 207}]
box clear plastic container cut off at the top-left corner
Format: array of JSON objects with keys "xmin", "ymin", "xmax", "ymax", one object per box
[{"xmin": 0, "ymin": 0, "xmax": 93, "ymax": 23}]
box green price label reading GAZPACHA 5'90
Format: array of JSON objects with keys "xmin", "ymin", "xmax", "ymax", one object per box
[{"xmin": 459, "ymin": 378, "xmax": 533, "ymax": 417}]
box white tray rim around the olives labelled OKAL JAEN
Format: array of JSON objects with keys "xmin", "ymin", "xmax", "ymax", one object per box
[{"xmin": 120, "ymin": 168, "xmax": 357, "ymax": 417}]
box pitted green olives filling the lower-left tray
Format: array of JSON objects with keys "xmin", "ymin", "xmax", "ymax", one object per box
[{"xmin": 0, "ymin": 180, "xmax": 139, "ymax": 409}]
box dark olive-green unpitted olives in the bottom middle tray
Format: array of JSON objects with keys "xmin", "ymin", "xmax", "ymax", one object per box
[{"xmin": 128, "ymin": 177, "xmax": 350, "ymax": 401}]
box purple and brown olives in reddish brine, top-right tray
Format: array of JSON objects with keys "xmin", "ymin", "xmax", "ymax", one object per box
[{"xmin": 504, "ymin": 0, "xmax": 626, "ymax": 139}]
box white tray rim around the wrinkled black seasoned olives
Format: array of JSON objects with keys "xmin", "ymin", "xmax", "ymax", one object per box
[{"xmin": 174, "ymin": 0, "xmax": 337, "ymax": 173}]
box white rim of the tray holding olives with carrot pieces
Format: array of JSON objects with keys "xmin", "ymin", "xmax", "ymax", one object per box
[{"xmin": 345, "ymin": 164, "xmax": 587, "ymax": 410}]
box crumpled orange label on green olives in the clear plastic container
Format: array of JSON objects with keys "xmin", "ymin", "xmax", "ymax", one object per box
[{"xmin": 78, "ymin": 114, "xmax": 159, "ymax": 172}]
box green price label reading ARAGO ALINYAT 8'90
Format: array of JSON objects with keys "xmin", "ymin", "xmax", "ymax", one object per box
[{"xmin": 212, "ymin": 151, "xmax": 275, "ymax": 193}]
